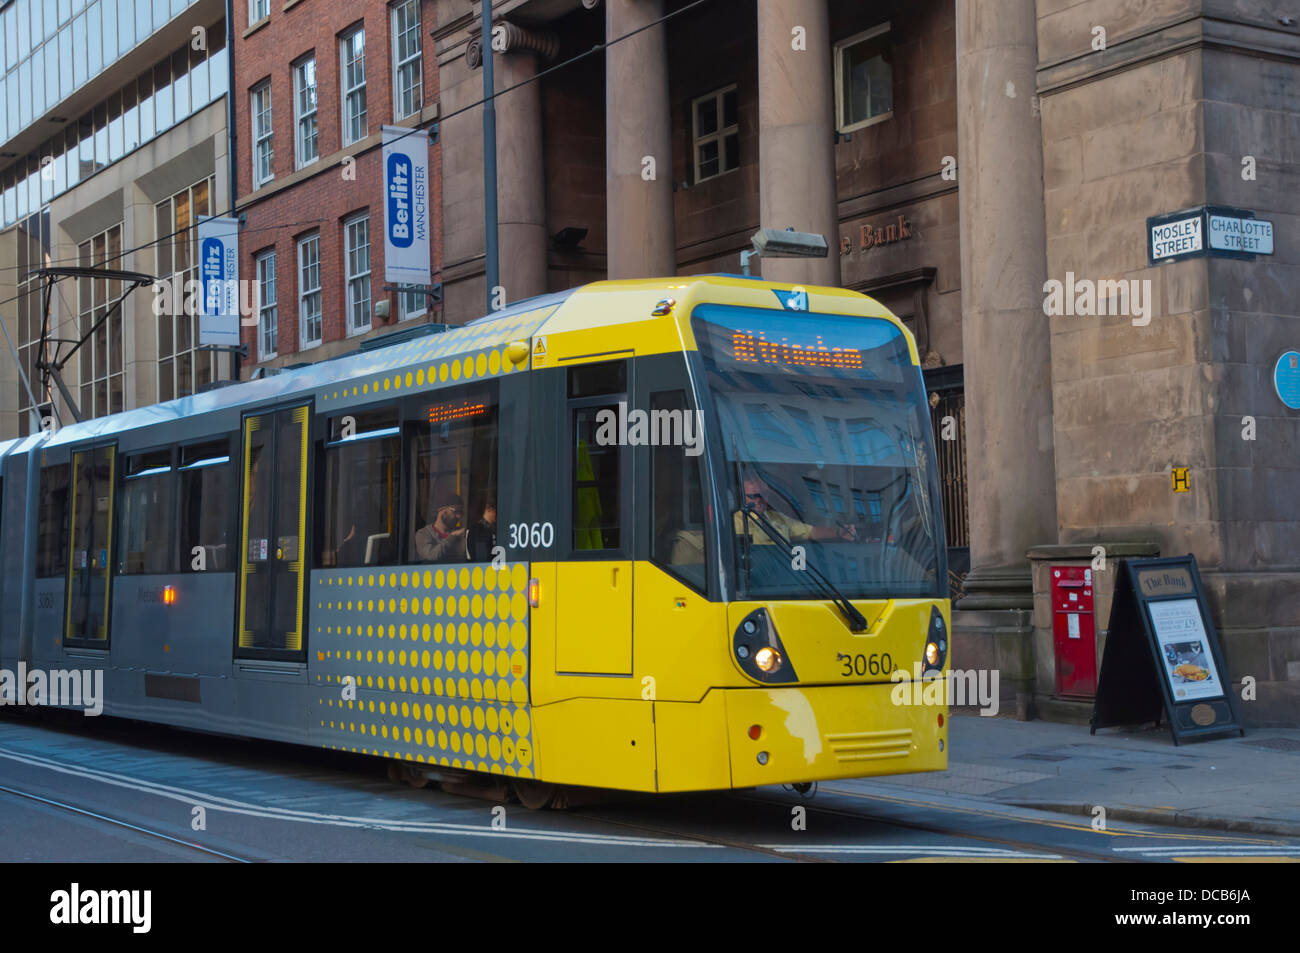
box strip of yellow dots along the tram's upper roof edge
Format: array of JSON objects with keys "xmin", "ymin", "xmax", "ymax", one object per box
[{"xmin": 317, "ymin": 304, "xmax": 558, "ymax": 408}]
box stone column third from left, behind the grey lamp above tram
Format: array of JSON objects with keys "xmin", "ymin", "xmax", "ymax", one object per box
[{"xmin": 758, "ymin": 0, "xmax": 840, "ymax": 286}]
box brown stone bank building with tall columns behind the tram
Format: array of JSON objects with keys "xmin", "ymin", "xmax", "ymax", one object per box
[{"xmin": 432, "ymin": 0, "xmax": 1300, "ymax": 723}]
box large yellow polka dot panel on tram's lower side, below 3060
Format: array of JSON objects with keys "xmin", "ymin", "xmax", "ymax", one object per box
[{"xmin": 308, "ymin": 563, "xmax": 536, "ymax": 777}]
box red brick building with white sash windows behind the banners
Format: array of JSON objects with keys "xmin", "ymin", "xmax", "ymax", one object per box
[{"xmin": 239, "ymin": 0, "xmax": 442, "ymax": 372}]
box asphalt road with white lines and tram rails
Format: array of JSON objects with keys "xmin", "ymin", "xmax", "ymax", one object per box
[{"xmin": 0, "ymin": 714, "xmax": 1300, "ymax": 863}]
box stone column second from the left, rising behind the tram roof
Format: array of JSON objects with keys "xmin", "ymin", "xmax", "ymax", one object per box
[{"xmin": 605, "ymin": 0, "xmax": 677, "ymax": 278}]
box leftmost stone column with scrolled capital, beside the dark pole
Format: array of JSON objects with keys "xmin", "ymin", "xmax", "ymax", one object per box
[{"xmin": 494, "ymin": 41, "xmax": 546, "ymax": 302}]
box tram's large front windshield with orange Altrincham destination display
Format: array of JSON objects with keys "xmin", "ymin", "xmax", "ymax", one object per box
[{"xmin": 693, "ymin": 304, "xmax": 946, "ymax": 598}]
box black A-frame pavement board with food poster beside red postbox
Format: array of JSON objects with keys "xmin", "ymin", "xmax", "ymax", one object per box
[{"xmin": 1091, "ymin": 555, "xmax": 1245, "ymax": 745}]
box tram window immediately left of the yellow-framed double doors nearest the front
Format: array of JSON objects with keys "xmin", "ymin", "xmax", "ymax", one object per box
[{"xmin": 177, "ymin": 439, "xmax": 238, "ymax": 572}]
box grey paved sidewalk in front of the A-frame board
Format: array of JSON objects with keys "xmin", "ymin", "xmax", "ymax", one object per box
[{"xmin": 874, "ymin": 711, "xmax": 1300, "ymax": 836}]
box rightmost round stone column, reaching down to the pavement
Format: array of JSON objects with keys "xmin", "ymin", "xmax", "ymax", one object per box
[{"xmin": 953, "ymin": 0, "xmax": 1057, "ymax": 716}]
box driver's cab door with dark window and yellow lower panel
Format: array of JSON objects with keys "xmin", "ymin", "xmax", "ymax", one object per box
[{"xmin": 555, "ymin": 360, "xmax": 632, "ymax": 675}]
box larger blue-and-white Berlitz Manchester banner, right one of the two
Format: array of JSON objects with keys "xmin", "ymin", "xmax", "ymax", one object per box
[{"xmin": 384, "ymin": 126, "xmax": 429, "ymax": 286}]
